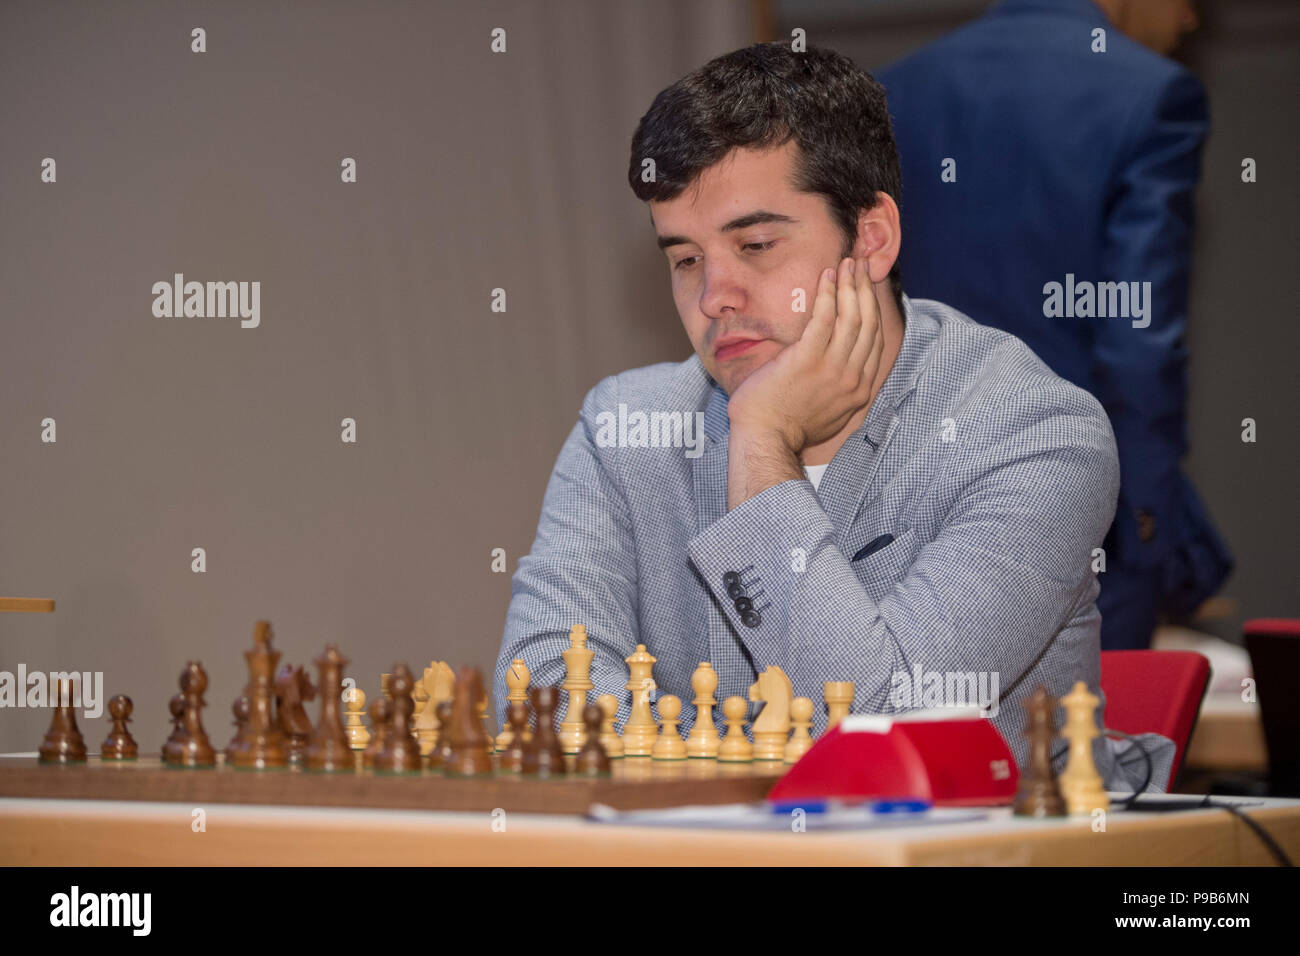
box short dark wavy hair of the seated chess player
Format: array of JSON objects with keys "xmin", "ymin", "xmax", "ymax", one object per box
[{"xmin": 628, "ymin": 40, "xmax": 902, "ymax": 312}]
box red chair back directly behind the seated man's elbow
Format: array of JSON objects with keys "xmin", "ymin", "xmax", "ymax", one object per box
[{"xmin": 1101, "ymin": 650, "xmax": 1210, "ymax": 792}]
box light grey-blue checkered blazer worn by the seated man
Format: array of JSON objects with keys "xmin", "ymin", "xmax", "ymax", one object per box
[{"xmin": 494, "ymin": 298, "xmax": 1174, "ymax": 791}]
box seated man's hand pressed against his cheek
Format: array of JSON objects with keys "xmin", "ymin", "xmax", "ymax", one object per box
[{"xmin": 728, "ymin": 259, "xmax": 884, "ymax": 455}]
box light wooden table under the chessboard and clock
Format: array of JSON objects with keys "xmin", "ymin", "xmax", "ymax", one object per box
[{"xmin": 0, "ymin": 760, "xmax": 1300, "ymax": 866}]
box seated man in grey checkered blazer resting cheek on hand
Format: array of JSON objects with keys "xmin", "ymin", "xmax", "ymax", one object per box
[{"xmin": 494, "ymin": 43, "xmax": 1173, "ymax": 788}]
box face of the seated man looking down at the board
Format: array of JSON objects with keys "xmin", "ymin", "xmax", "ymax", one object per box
[{"xmin": 650, "ymin": 140, "xmax": 849, "ymax": 394}]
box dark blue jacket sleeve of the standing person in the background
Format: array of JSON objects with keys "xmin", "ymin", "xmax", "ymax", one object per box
[{"xmin": 1091, "ymin": 70, "xmax": 1209, "ymax": 568}]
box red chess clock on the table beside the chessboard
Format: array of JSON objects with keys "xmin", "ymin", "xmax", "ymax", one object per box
[{"xmin": 768, "ymin": 709, "xmax": 1019, "ymax": 806}]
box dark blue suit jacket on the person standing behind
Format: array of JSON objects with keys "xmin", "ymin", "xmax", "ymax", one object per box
[{"xmin": 879, "ymin": 0, "xmax": 1231, "ymax": 613}]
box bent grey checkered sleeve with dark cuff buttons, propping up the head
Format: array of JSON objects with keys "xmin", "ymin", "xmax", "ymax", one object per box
[{"xmin": 689, "ymin": 381, "xmax": 1118, "ymax": 713}]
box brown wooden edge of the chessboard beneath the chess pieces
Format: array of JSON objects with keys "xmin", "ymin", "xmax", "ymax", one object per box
[{"xmin": 0, "ymin": 754, "xmax": 788, "ymax": 814}]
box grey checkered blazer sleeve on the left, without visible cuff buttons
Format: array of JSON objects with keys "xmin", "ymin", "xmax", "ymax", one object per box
[{"xmin": 493, "ymin": 378, "xmax": 637, "ymax": 723}]
